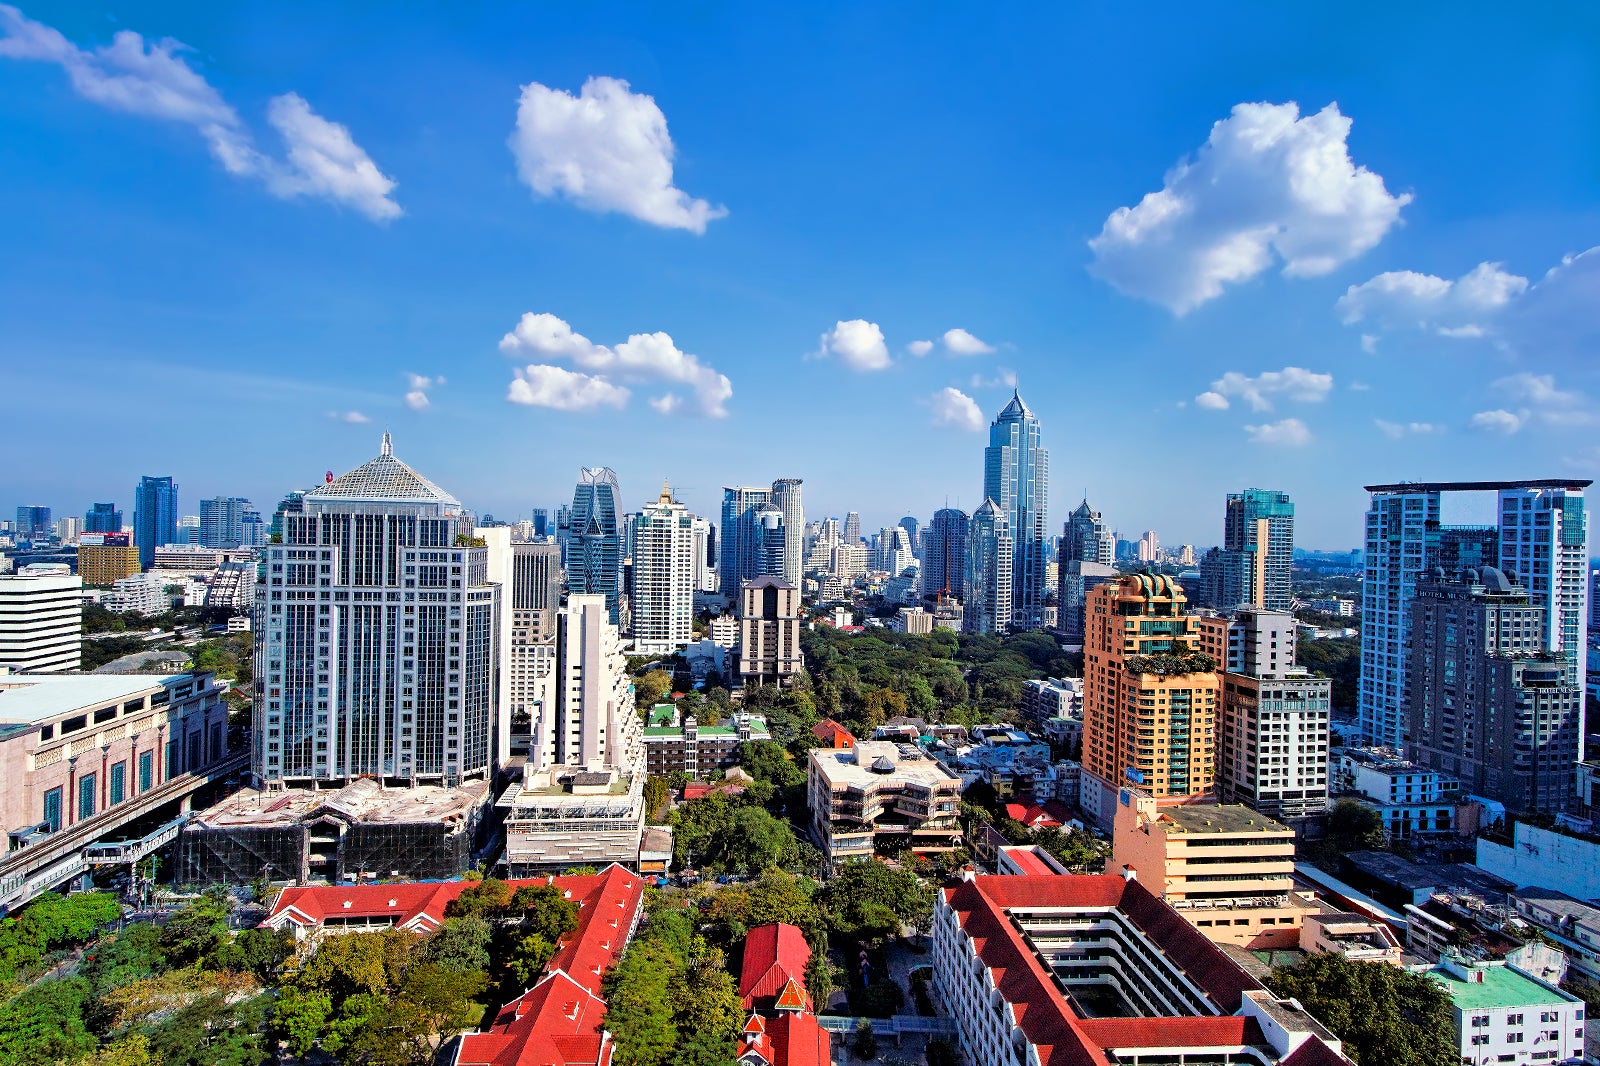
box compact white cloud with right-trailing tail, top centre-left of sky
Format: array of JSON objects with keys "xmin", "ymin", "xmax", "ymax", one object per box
[{"xmin": 510, "ymin": 77, "xmax": 728, "ymax": 234}]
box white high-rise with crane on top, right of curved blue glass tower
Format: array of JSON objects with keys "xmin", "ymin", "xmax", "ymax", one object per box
[{"xmin": 632, "ymin": 482, "xmax": 696, "ymax": 655}]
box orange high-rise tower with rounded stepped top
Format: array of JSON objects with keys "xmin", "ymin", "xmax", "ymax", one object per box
[{"xmin": 1083, "ymin": 573, "xmax": 1222, "ymax": 813}]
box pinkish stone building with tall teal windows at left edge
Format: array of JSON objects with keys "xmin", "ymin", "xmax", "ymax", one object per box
[{"xmin": 0, "ymin": 671, "xmax": 242, "ymax": 908}]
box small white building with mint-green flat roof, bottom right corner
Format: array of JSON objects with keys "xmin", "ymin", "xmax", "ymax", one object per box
[{"xmin": 1429, "ymin": 956, "xmax": 1584, "ymax": 1064}]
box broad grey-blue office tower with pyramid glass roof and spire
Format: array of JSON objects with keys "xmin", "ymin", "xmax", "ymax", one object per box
[{"xmin": 251, "ymin": 434, "xmax": 501, "ymax": 787}]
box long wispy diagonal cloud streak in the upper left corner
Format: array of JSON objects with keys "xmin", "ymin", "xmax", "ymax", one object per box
[{"xmin": 0, "ymin": 5, "xmax": 400, "ymax": 221}]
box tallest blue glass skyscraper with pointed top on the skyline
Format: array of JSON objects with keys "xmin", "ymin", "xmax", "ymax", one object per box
[{"xmin": 984, "ymin": 391, "xmax": 1050, "ymax": 632}]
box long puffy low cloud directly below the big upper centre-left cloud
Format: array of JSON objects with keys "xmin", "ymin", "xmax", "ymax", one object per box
[{"xmin": 499, "ymin": 312, "xmax": 733, "ymax": 418}]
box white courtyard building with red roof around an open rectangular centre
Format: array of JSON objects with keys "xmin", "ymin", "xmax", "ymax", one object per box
[{"xmin": 931, "ymin": 874, "xmax": 1349, "ymax": 1066}]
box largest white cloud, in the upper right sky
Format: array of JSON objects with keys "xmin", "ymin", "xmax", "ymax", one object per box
[{"xmin": 1090, "ymin": 102, "xmax": 1411, "ymax": 314}]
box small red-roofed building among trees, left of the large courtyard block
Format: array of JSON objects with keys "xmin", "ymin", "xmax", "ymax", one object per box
[{"xmin": 739, "ymin": 925, "xmax": 829, "ymax": 1066}]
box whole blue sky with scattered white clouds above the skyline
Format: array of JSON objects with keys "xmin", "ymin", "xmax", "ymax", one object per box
[{"xmin": 0, "ymin": 3, "xmax": 1600, "ymax": 547}]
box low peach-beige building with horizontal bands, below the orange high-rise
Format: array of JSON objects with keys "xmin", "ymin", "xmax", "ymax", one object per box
[{"xmin": 1112, "ymin": 789, "xmax": 1317, "ymax": 949}]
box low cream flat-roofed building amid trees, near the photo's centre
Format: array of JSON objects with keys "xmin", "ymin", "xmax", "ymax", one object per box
[{"xmin": 806, "ymin": 741, "xmax": 962, "ymax": 863}]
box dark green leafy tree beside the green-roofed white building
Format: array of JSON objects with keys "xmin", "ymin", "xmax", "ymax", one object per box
[{"xmin": 1267, "ymin": 954, "xmax": 1458, "ymax": 1066}]
